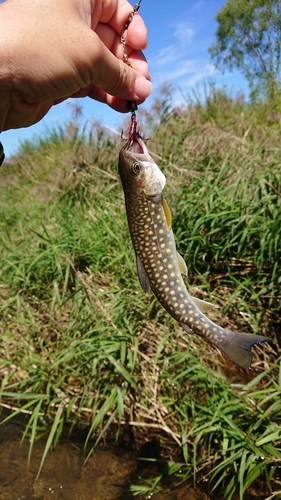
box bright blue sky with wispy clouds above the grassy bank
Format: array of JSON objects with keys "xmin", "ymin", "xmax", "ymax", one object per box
[{"xmin": 0, "ymin": 0, "xmax": 247, "ymax": 156}]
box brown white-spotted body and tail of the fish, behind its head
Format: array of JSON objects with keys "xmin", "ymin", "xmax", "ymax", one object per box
[{"xmin": 125, "ymin": 193, "xmax": 269, "ymax": 368}]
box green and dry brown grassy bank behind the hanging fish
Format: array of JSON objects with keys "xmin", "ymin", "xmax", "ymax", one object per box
[{"xmin": 0, "ymin": 87, "xmax": 281, "ymax": 499}]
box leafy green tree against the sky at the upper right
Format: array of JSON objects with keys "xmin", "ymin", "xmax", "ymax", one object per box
[{"xmin": 209, "ymin": 0, "xmax": 281, "ymax": 100}]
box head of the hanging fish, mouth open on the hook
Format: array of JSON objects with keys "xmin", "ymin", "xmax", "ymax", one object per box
[{"xmin": 119, "ymin": 136, "xmax": 166, "ymax": 203}]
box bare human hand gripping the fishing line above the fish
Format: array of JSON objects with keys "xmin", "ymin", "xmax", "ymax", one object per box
[{"xmin": 0, "ymin": 0, "xmax": 151, "ymax": 132}]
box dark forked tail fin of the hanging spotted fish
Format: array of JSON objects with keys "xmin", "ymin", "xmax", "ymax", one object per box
[{"xmin": 216, "ymin": 331, "xmax": 271, "ymax": 368}]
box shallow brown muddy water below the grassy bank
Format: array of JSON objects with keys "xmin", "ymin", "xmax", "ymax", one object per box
[{"xmin": 0, "ymin": 414, "xmax": 208, "ymax": 500}]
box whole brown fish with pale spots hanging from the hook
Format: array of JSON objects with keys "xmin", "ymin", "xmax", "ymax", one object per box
[{"xmin": 118, "ymin": 131, "xmax": 270, "ymax": 368}]
